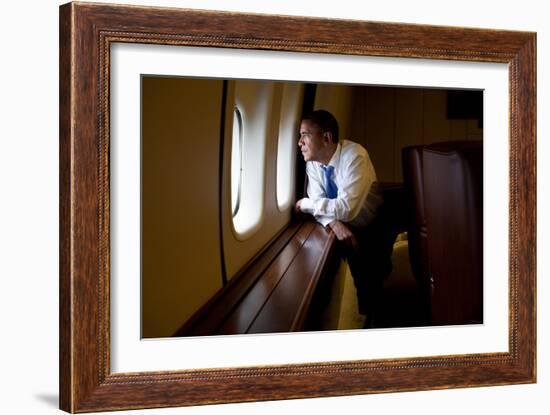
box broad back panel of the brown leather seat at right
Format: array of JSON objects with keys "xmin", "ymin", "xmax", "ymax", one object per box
[{"xmin": 423, "ymin": 141, "xmax": 483, "ymax": 324}]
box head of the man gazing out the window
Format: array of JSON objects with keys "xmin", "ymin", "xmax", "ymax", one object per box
[{"xmin": 298, "ymin": 110, "xmax": 338, "ymax": 164}]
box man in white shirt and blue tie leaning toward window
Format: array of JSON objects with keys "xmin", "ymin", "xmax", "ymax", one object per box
[{"xmin": 296, "ymin": 110, "xmax": 393, "ymax": 326}]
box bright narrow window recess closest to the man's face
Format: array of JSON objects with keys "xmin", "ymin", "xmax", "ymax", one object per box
[{"xmin": 277, "ymin": 84, "xmax": 303, "ymax": 211}]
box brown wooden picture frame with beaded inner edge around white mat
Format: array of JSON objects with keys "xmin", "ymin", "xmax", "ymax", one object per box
[{"xmin": 60, "ymin": 3, "xmax": 536, "ymax": 412}]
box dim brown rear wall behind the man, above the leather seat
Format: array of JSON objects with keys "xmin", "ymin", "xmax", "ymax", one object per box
[{"xmin": 350, "ymin": 87, "xmax": 483, "ymax": 182}]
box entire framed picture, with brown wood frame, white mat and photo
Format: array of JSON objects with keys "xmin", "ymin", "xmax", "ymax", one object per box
[{"xmin": 60, "ymin": 3, "xmax": 536, "ymax": 413}]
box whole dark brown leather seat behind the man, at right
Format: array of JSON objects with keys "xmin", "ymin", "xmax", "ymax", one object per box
[{"xmin": 403, "ymin": 141, "xmax": 483, "ymax": 325}]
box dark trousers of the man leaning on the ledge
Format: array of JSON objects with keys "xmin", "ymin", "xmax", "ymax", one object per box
[{"xmin": 342, "ymin": 210, "xmax": 397, "ymax": 324}]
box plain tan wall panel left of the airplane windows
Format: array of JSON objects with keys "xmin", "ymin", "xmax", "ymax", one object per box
[{"xmin": 141, "ymin": 77, "xmax": 223, "ymax": 337}]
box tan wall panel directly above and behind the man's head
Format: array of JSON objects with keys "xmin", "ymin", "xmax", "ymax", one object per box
[{"xmin": 314, "ymin": 84, "xmax": 353, "ymax": 139}]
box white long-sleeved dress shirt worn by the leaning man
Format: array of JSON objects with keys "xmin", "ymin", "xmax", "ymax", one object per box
[{"xmin": 300, "ymin": 140, "xmax": 382, "ymax": 227}]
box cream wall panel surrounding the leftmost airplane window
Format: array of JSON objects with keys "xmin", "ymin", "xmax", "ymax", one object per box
[{"xmin": 222, "ymin": 80, "xmax": 303, "ymax": 279}]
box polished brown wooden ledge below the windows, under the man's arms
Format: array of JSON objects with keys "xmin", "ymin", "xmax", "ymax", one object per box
[{"xmin": 175, "ymin": 220, "xmax": 338, "ymax": 337}]
